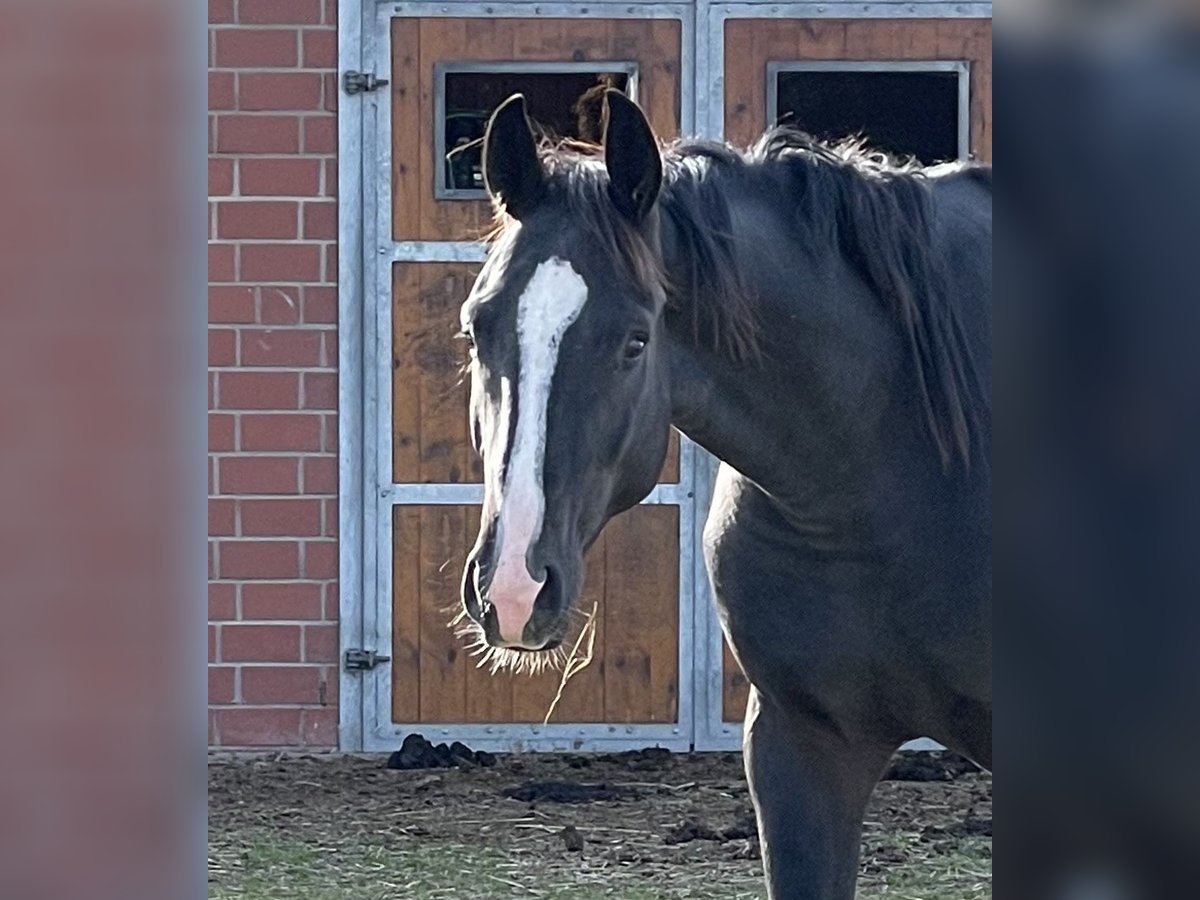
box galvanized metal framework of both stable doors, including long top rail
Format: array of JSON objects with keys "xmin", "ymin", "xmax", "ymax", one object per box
[{"xmin": 337, "ymin": 0, "xmax": 991, "ymax": 751}]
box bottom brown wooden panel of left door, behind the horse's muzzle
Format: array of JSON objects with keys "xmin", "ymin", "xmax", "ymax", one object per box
[{"xmin": 391, "ymin": 505, "xmax": 679, "ymax": 725}]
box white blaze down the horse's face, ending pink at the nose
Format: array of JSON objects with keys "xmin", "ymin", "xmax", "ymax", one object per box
[{"xmin": 487, "ymin": 258, "xmax": 588, "ymax": 643}]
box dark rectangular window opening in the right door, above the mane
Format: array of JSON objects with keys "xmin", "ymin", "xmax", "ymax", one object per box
[{"xmin": 770, "ymin": 70, "xmax": 965, "ymax": 164}]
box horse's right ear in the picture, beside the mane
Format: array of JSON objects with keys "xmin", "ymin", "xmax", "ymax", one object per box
[{"xmin": 604, "ymin": 89, "xmax": 662, "ymax": 223}]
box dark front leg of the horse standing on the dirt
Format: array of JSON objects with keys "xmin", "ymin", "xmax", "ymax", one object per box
[{"xmin": 744, "ymin": 689, "xmax": 894, "ymax": 900}]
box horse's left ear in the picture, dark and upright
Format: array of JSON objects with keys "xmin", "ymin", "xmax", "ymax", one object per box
[{"xmin": 484, "ymin": 94, "xmax": 546, "ymax": 218}]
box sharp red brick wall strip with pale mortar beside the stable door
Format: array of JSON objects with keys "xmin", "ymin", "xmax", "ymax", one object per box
[{"xmin": 209, "ymin": 0, "xmax": 337, "ymax": 748}]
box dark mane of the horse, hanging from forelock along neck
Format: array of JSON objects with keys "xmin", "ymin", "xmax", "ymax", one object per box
[{"xmin": 490, "ymin": 126, "xmax": 991, "ymax": 468}]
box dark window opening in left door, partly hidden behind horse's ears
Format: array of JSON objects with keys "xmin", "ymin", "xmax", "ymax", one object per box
[{"xmin": 437, "ymin": 64, "xmax": 634, "ymax": 199}]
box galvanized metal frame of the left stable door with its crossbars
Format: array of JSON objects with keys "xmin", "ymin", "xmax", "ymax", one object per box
[{"xmin": 342, "ymin": 0, "xmax": 696, "ymax": 751}]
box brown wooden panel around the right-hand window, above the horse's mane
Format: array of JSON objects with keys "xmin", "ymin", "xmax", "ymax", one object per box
[{"xmin": 725, "ymin": 19, "xmax": 991, "ymax": 162}]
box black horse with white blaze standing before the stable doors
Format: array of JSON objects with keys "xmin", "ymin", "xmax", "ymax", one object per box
[{"xmin": 453, "ymin": 92, "xmax": 991, "ymax": 900}]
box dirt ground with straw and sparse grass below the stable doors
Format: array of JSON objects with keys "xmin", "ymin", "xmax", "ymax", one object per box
[{"xmin": 209, "ymin": 752, "xmax": 991, "ymax": 900}]
